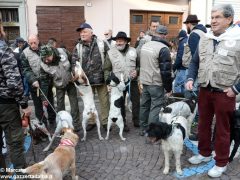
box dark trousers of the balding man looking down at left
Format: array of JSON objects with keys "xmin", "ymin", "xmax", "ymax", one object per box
[{"xmin": 29, "ymin": 86, "xmax": 56, "ymax": 123}]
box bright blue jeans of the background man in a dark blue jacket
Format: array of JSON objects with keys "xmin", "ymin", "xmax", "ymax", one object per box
[{"xmin": 173, "ymin": 69, "xmax": 187, "ymax": 93}]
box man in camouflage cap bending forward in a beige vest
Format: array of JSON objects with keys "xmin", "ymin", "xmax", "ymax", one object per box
[{"xmin": 40, "ymin": 45, "xmax": 80, "ymax": 132}]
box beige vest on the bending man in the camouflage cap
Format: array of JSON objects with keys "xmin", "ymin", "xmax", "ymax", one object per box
[{"xmin": 41, "ymin": 48, "xmax": 72, "ymax": 88}]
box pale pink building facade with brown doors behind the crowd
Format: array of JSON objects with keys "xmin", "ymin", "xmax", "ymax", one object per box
[{"xmin": 0, "ymin": 0, "xmax": 240, "ymax": 50}]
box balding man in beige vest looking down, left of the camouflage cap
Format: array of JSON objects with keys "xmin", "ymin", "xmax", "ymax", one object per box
[{"xmin": 20, "ymin": 35, "xmax": 56, "ymax": 125}]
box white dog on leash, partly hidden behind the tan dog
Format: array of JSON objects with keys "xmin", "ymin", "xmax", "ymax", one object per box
[{"xmin": 43, "ymin": 111, "xmax": 74, "ymax": 151}]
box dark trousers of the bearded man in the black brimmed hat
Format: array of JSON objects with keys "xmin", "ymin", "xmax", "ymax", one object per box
[{"xmin": 124, "ymin": 81, "xmax": 140, "ymax": 125}]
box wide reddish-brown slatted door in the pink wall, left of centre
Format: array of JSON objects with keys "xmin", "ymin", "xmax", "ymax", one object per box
[{"xmin": 36, "ymin": 6, "xmax": 85, "ymax": 51}]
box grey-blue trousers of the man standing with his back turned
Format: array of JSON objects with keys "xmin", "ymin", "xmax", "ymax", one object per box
[{"xmin": 139, "ymin": 85, "xmax": 164, "ymax": 130}]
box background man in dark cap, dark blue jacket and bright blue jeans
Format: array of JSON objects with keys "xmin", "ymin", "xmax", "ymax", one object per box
[{"xmin": 173, "ymin": 30, "xmax": 188, "ymax": 93}]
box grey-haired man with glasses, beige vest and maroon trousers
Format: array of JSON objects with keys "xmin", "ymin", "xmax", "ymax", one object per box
[{"xmin": 186, "ymin": 4, "xmax": 240, "ymax": 177}]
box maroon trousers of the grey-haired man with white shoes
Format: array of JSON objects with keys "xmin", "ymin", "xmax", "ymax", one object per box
[{"xmin": 198, "ymin": 88, "xmax": 235, "ymax": 167}]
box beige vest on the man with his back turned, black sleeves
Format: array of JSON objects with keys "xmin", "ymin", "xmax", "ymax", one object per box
[{"xmin": 140, "ymin": 41, "xmax": 168, "ymax": 86}]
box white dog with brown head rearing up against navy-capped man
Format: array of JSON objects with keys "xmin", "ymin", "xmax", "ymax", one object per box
[{"xmin": 74, "ymin": 62, "xmax": 103, "ymax": 141}]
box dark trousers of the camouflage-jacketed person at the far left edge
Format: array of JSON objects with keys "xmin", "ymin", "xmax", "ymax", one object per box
[{"xmin": 0, "ymin": 103, "xmax": 26, "ymax": 169}]
